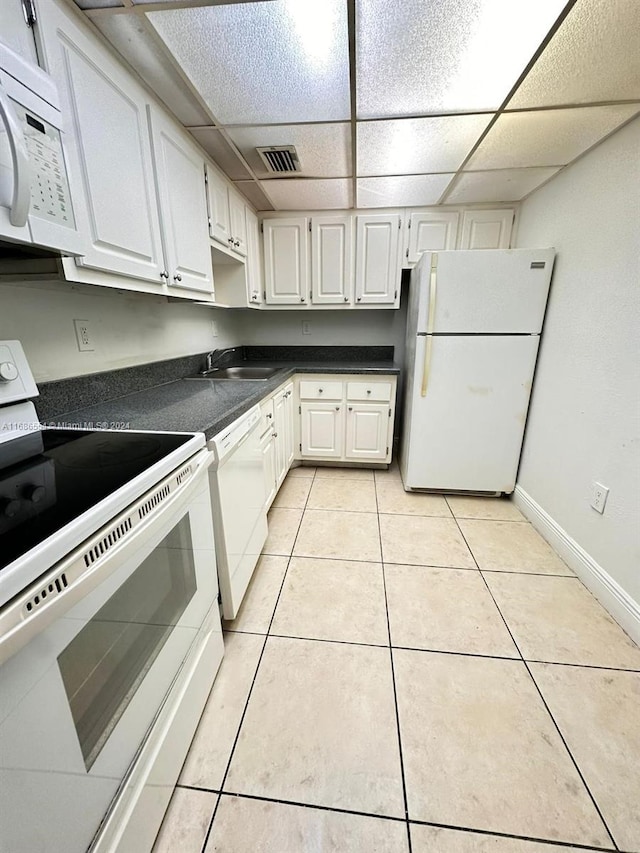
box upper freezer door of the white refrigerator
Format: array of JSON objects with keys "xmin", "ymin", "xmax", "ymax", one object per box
[{"xmin": 411, "ymin": 249, "xmax": 555, "ymax": 334}]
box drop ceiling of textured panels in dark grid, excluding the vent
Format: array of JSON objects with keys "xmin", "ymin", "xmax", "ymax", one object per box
[{"xmin": 80, "ymin": 0, "xmax": 640, "ymax": 210}]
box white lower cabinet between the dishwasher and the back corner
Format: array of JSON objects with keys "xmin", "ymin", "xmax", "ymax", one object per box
[{"xmin": 260, "ymin": 382, "xmax": 294, "ymax": 509}]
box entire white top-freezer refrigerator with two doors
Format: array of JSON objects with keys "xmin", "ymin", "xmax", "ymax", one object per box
[{"xmin": 400, "ymin": 249, "xmax": 555, "ymax": 493}]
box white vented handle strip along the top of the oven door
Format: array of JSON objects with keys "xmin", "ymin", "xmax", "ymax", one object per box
[{"xmin": 0, "ymin": 448, "xmax": 214, "ymax": 664}]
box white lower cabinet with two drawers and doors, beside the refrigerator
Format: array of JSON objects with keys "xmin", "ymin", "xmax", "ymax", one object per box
[{"xmin": 298, "ymin": 375, "xmax": 396, "ymax": 462}]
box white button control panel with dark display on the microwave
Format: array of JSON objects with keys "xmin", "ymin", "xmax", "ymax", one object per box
[{"xmin": 13, "ymin": 101, "xmax": 75, "ymax": 228}]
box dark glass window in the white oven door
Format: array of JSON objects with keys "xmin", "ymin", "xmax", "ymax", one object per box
[{"xmin": 58, "ymin": 518, "xmax": 197, "ymax": 770}]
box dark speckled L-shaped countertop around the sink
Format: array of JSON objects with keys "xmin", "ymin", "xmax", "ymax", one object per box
[{"xmin": 41, "ymin": 352, "xmax": 400, "ymax": 438}]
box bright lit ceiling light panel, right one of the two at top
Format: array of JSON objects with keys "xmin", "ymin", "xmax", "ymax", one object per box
[{"xmin": 356, "ymin": 0, "xmax": 565, "ymax": 118}]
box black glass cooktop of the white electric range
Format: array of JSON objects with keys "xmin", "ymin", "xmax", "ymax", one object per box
[{"xmin": 0, "ymin": 429, "xmax": 191, "ymax": 569}]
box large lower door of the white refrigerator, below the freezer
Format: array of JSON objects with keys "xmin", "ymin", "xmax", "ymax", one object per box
[{"xmin": 400, "ymin": 335, "xmax": 539, "ymax": 492}]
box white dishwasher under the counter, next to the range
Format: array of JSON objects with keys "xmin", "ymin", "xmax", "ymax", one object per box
[{"xmin": 207, "ymin": 406, "xmax": 267, "ymax": 619}]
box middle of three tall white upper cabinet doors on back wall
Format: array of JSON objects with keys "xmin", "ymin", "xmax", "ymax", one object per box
[{"xmin": 311, "ymin": 216, "xmax": 353, "ymax": 305}]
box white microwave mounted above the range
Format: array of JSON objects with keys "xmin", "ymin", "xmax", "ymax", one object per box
[{"xmin": 0, "ymin": 42, "xmax": 82, "ymax": 256}]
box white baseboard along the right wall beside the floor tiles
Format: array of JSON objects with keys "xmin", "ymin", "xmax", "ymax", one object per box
[{"xmin": 513, "ymin": 486, "xmax": 640, "ymax": 645}]
